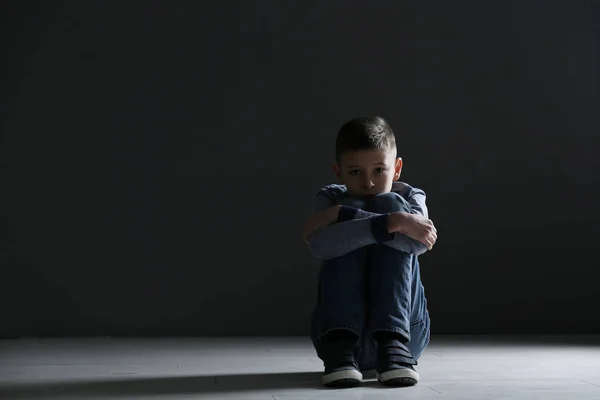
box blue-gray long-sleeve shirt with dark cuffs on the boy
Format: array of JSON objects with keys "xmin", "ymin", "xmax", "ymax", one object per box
[{"xmin": 307, "ymin": 182, "xmax": 429, "ymax": 259}]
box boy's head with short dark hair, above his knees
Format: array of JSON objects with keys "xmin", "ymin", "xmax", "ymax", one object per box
[{"xmin": 333, "ymin": 117, "xmax": 402, "ymax": 197}]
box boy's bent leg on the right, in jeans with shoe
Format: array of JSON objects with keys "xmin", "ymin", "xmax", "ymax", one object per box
[{"xmin": 360, "ymin": 193, "xmax": 429, "ymax": 385}]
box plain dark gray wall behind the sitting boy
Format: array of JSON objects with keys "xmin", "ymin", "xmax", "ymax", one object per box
[{"xmin": 0, "ymin": 0, "xmax": 600, "ymax": 336}]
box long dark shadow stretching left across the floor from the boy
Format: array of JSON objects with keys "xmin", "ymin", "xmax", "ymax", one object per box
[{"xmin": 0, "ymin": 372, "xmax": 376, "ymax": 399}]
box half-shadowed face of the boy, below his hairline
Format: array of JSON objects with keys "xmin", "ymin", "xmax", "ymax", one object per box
[{"xmin": 333, "ymin": 149, "xmax": 402, "ymax": 197}]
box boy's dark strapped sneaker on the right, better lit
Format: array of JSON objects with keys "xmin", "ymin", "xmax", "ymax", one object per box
[{"xmin": 377, "ymin": 340, "xmax": 419, "ymax": 386}]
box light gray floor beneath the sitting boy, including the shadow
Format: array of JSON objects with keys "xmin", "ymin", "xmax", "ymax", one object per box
[{"xmin": 0, "ymin": 337, "xmax": 600, "ymax": 400}]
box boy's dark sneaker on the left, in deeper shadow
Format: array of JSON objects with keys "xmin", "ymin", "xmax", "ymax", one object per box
[{"xmin": 323, "ymin": 341, "xmax": 362, "ymax": 388}]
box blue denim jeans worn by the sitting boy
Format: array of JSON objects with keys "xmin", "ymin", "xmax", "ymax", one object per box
[{"xmin": 311, "ymin": 192, "xmax": 430, "ymax": 371}]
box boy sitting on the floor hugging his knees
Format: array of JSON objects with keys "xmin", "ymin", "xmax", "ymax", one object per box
[{"xmin": 302, "ymin": 117, "xmax": 437, "ymax": 387}]
